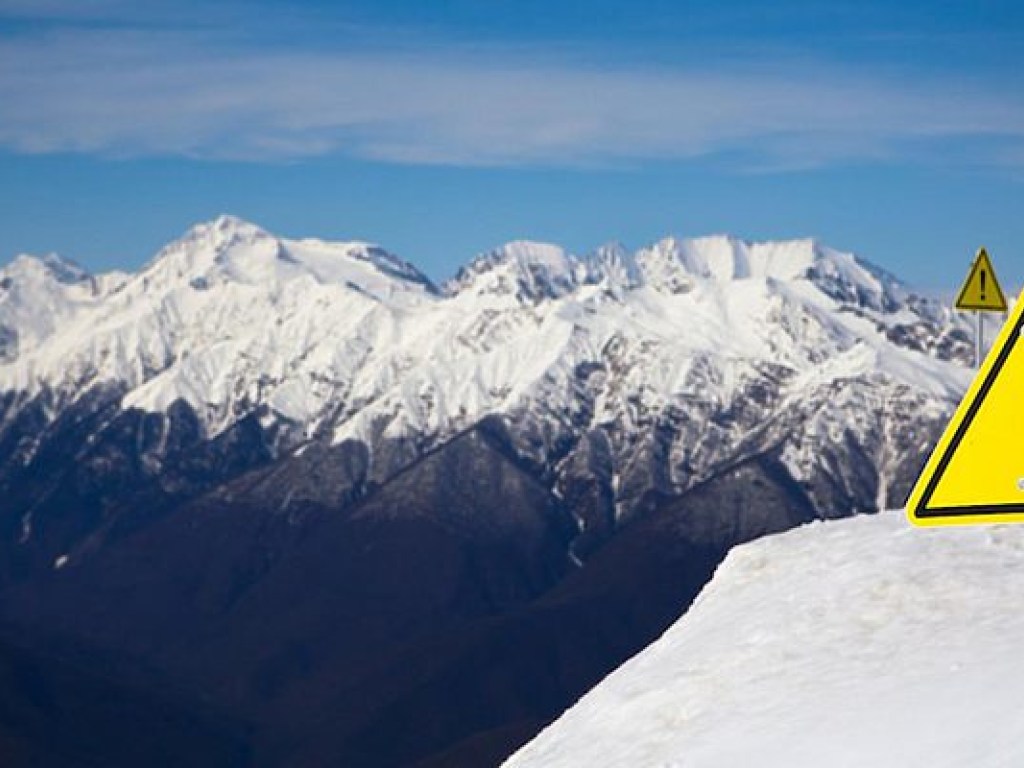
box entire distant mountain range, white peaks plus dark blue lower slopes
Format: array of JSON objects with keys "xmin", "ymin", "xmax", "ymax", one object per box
[{"xmin": 0, "ymin": 216, "xmax": 973, "ymax": 765}]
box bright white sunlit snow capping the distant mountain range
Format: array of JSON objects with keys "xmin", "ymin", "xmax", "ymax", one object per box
[{"xmin": 0, "ymin": 216, "xmax": 970, "ymax": 450}]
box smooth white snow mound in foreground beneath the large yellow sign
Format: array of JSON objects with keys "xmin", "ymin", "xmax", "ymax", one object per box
[{"xmin": 506, "ymin": 512, "xmax": 1024, "ymax": 768}]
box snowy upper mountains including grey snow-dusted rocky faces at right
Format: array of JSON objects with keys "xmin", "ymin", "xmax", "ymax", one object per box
[{"xmin": 0, "ymin": 216, "xmax": 970, "ymax": 517}]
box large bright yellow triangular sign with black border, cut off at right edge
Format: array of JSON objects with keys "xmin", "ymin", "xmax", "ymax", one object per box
[{"xmin": 906, "ymin": 294, "xmax": 1024, "ymax": 525}]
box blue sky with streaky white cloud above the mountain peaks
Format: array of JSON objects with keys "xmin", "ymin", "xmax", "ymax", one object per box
[{"xmin": 0, "ymin": 0, "xmax": 1024, "ymax": 292}]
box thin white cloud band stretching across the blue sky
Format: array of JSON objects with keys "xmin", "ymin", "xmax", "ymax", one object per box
[{"xmin": 0, "ymin": 29, "xmax": 1024, "ymax": 169}]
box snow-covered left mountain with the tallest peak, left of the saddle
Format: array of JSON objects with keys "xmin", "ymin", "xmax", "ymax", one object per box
[{"xmin": 0, "ymin": 216, "xmax": 434, "ymax": 434}]
